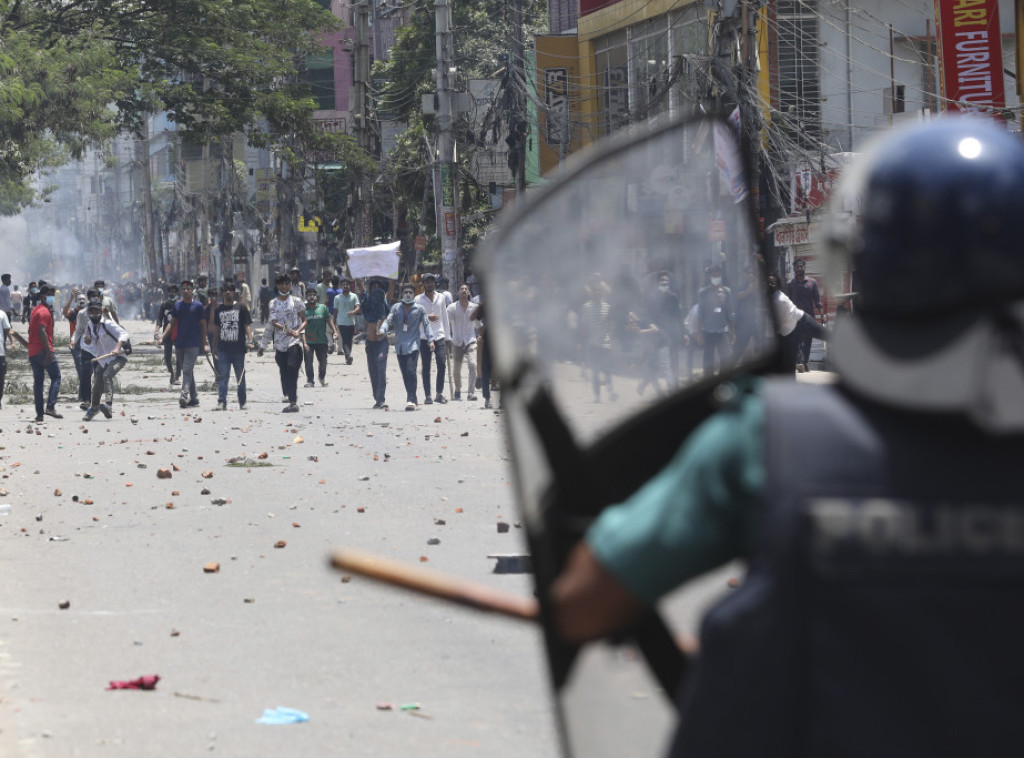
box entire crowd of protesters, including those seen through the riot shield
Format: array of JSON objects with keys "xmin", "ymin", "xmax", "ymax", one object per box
[{"xmin": 0, "ymin": 258, "xmax": 825, "ymax": 421}]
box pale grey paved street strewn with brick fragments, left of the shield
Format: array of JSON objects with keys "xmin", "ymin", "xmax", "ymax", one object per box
[{"xmin": 0, "ymin": 323, "xmax": 557, "ymax": 756}]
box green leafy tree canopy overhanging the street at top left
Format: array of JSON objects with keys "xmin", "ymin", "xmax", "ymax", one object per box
[{"xmin": 0, "ymin": 0, "xmax": 338, "ymax": 214}]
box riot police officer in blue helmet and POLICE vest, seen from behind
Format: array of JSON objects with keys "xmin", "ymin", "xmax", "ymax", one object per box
[{"xmin": 551, "ymin": 117, "xmax": 1024, "ymax": 758}]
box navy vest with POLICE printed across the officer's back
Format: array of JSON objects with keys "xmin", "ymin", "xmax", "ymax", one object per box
[{"xmin": 673, "ymin": 381, "xmax": 1024, "ymax": 758}]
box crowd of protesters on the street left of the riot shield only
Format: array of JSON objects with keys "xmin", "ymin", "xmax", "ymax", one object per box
[{"xmin": 0, "ymin": 268, "xmax": 490, "ymax": 423}]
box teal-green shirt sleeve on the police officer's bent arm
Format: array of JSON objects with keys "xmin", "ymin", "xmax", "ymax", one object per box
[{"xmin": 586, "ymin": 391, "xmax": 765, "ymax": 603}]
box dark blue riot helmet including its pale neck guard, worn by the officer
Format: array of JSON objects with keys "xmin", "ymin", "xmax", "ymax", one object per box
[{"xmin": 825, "ymin": 116, "xmax": 1024, "ymax": 434}]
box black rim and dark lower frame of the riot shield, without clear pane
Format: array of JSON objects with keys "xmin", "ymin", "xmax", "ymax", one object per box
[{"xmin": 474, "ymin": 111, "xmax": 781, "ymax": 755}]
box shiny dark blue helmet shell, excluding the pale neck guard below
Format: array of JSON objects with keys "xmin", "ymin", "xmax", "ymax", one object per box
[{"xmin": 826, "ymin": 116, "xmax": 1024, "ymax": 317}]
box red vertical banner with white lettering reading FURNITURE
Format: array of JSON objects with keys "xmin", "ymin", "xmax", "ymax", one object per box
[{"xmin": 935, "ymin": 0, "xmax": 1007, "ymax": 112}]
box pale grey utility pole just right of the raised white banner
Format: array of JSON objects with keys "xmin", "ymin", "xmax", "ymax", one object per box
[{"xmin": 434, "ymin": 0, "xmax": 461, "ymax": 286}]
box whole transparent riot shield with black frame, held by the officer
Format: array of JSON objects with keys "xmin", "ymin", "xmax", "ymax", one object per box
[{"xmin": 477, "ymin": 119, "xmax": 777, "ymax": 756}]
